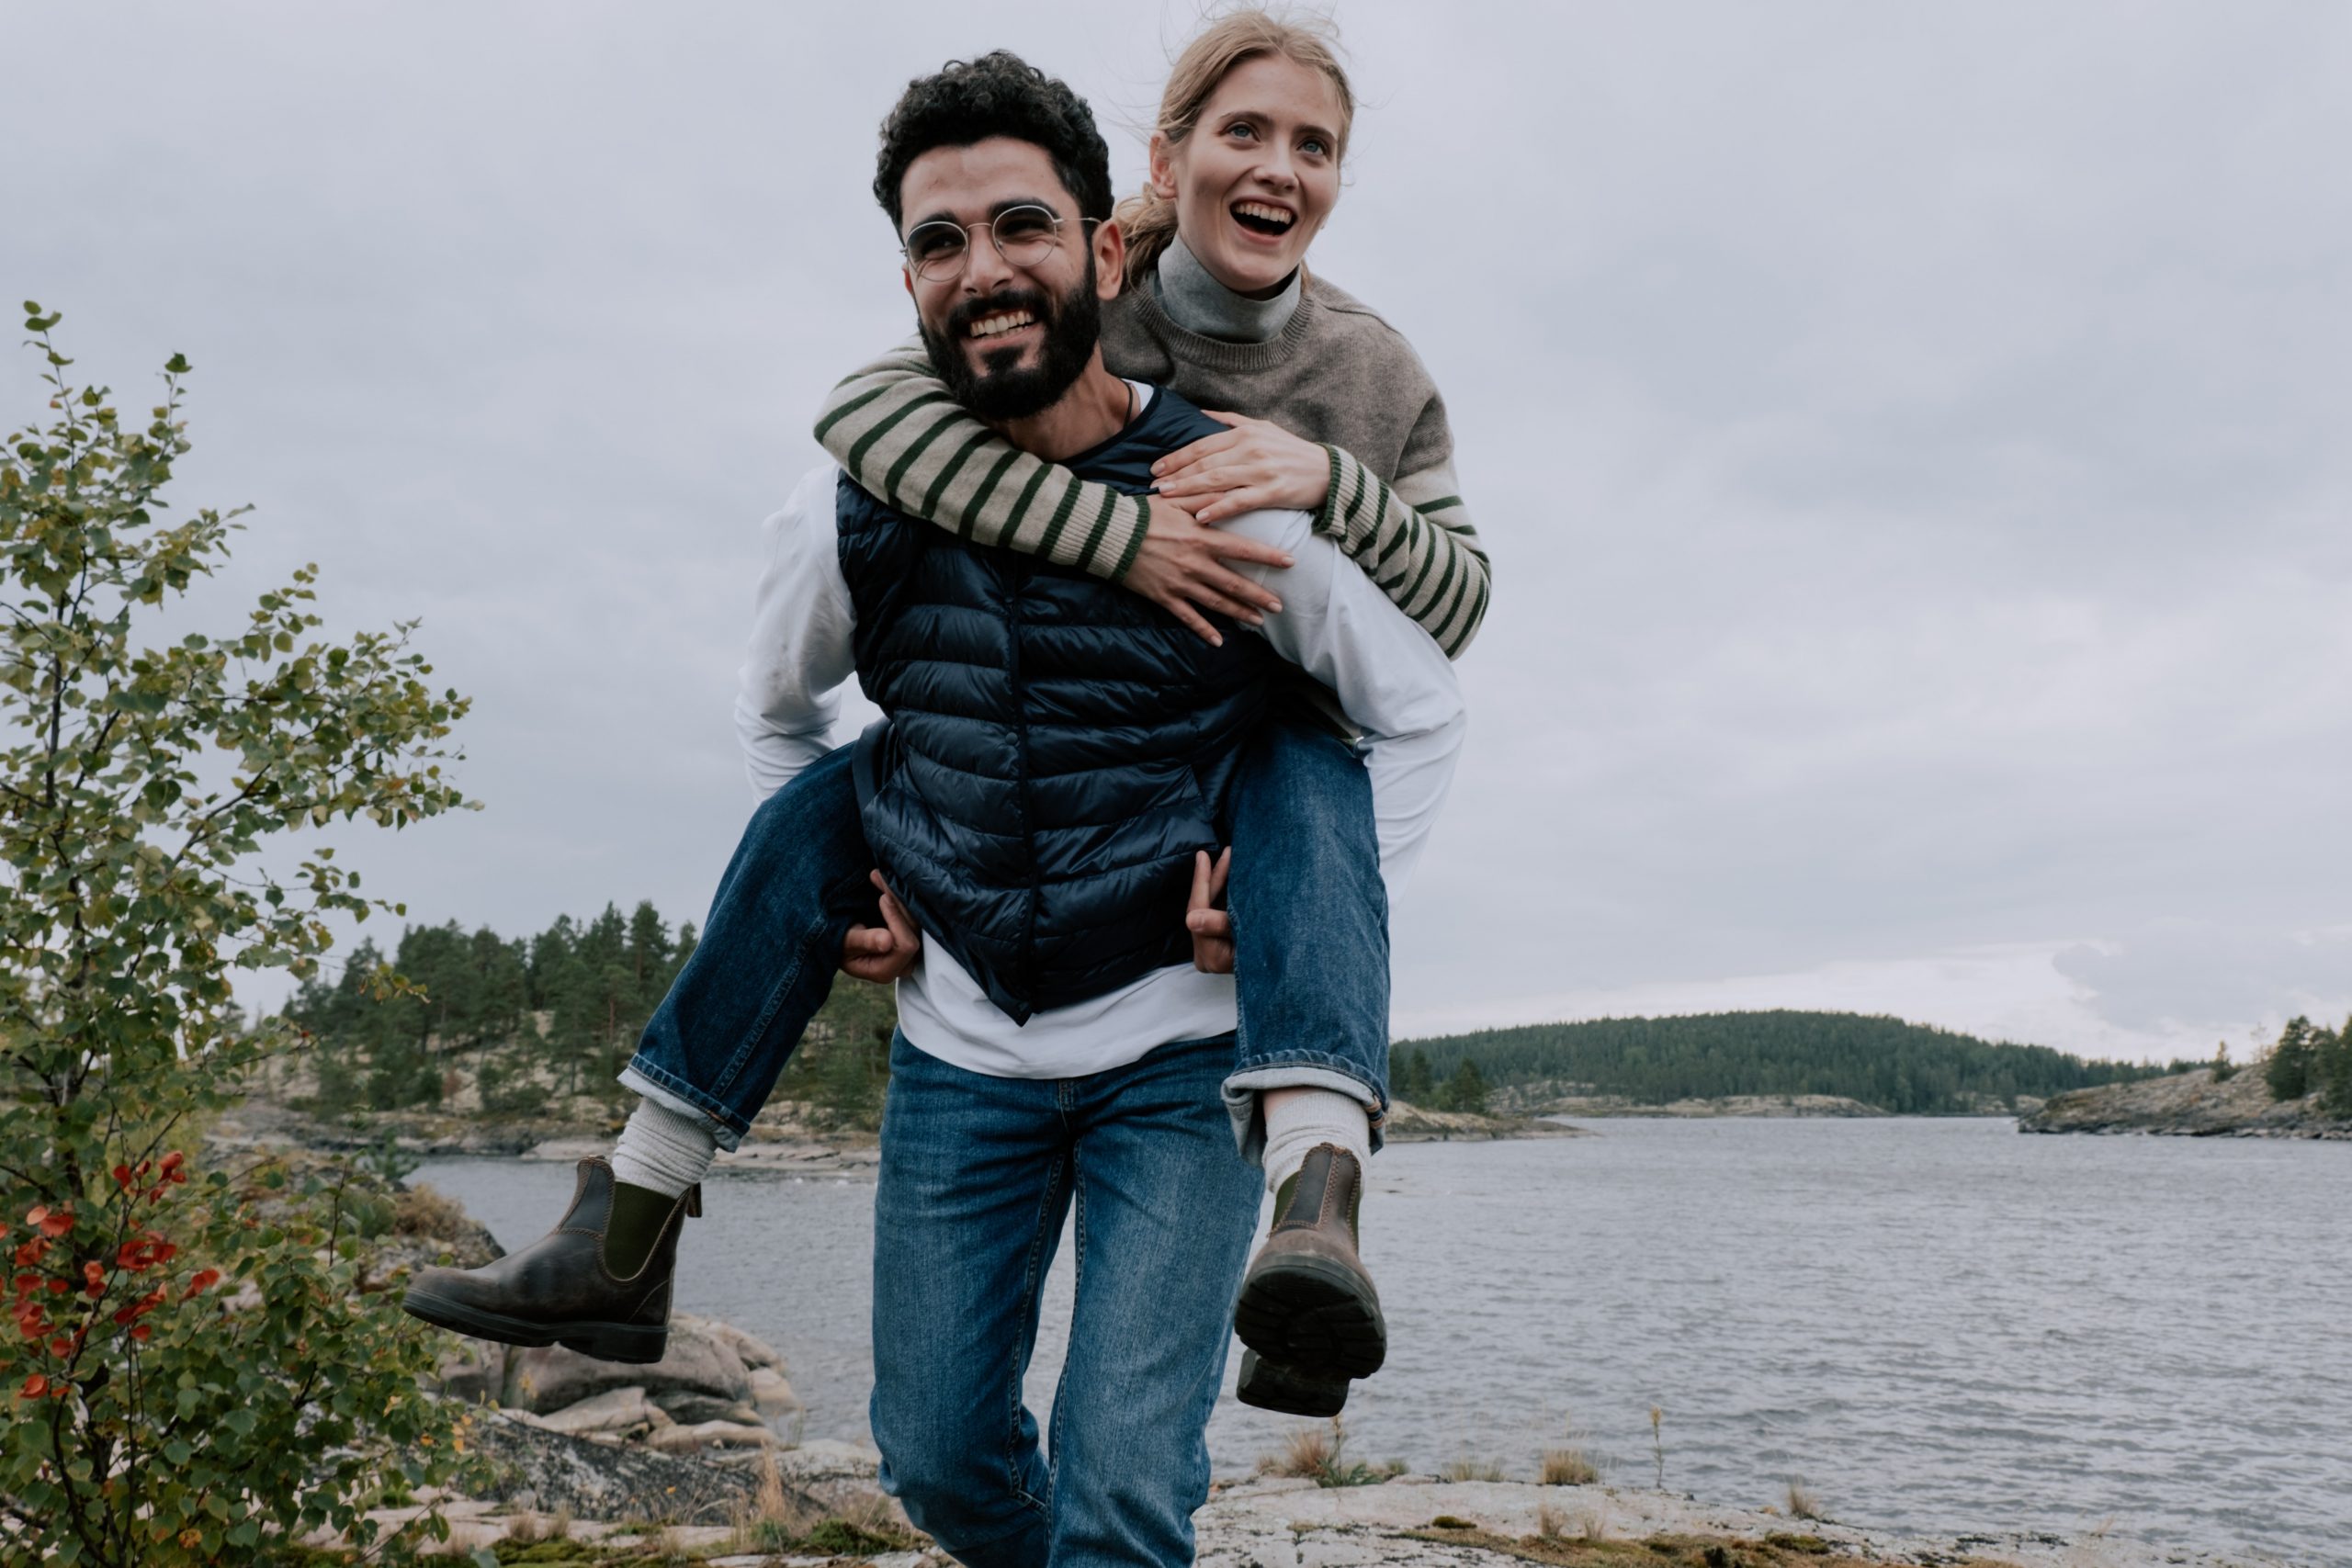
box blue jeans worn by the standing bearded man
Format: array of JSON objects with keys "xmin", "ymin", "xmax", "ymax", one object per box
[{"xmin": 870, "ymin": 1034, "xmax": 1261, "ymax": 1568}]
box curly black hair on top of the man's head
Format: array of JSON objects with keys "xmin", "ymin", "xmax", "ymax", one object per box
[{"xmin": 875, "ymin": 50, "xmax": 1110, "ymax": 228}]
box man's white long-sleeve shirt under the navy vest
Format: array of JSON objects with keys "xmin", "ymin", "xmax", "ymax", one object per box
[{"xmin": 736, "ymin": 388, "xmax": 1467, "ymax": 1079}]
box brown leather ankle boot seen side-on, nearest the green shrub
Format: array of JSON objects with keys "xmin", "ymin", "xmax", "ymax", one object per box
[{"xmin": 400, "ymin": 1156, "xmax": 703, "ymax": 1363}]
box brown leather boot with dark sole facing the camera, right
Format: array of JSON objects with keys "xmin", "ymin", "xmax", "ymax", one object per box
[{"xmin": 1232, "ymin": 1143, "xmax": 1387, "ymax": 1404}]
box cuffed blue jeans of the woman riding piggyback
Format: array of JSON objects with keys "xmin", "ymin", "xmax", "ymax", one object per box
[{"xmin": 621, "ymin": 717, "xmax": 1387, "ymax": 1159}]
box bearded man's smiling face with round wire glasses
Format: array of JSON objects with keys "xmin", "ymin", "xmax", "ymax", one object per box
[{"xmin": 899, "ymin": 136, "xmax": 1120, "ymax": 421}]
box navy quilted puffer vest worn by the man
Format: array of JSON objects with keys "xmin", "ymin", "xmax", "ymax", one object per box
[{"xmin": 837, "ymin": 390, "xmax": 1275, "ymax": 1022}]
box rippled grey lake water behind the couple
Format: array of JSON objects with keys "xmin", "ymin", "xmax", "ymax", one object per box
[{"xmin": 414, "ymin": 1119, "xmax": 2352, "ymax": 1561}]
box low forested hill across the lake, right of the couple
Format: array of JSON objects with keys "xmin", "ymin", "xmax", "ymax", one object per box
[{"xmin": 1393, "ymin": 1010, "xmax": 2164, "ymax": 1117}]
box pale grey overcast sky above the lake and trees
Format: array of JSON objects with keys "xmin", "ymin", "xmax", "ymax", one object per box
[{"xmin": 0, "ymin": 0, "xmax": 2352, "ymax": 1055}]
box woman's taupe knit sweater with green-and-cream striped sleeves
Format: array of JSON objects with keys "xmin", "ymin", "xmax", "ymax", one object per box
[{"xmin": 816, "ymin": 273, "xmax": 1487, "ymax": 659}]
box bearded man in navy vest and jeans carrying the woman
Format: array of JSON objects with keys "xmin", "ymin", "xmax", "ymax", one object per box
[{"xmin": 746, "ymin": 54, "xmax": 1463, "ymax": 1568}]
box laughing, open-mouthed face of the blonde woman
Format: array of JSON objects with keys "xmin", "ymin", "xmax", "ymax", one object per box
[{"xmin": 1152, "ymin": 54, "xmax": 1340, "ymax": 294}]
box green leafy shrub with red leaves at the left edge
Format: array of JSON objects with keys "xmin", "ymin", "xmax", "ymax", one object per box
[{"xmin": 0, "ymin": 306, "xmax": 466, "ymax": 1568}]
